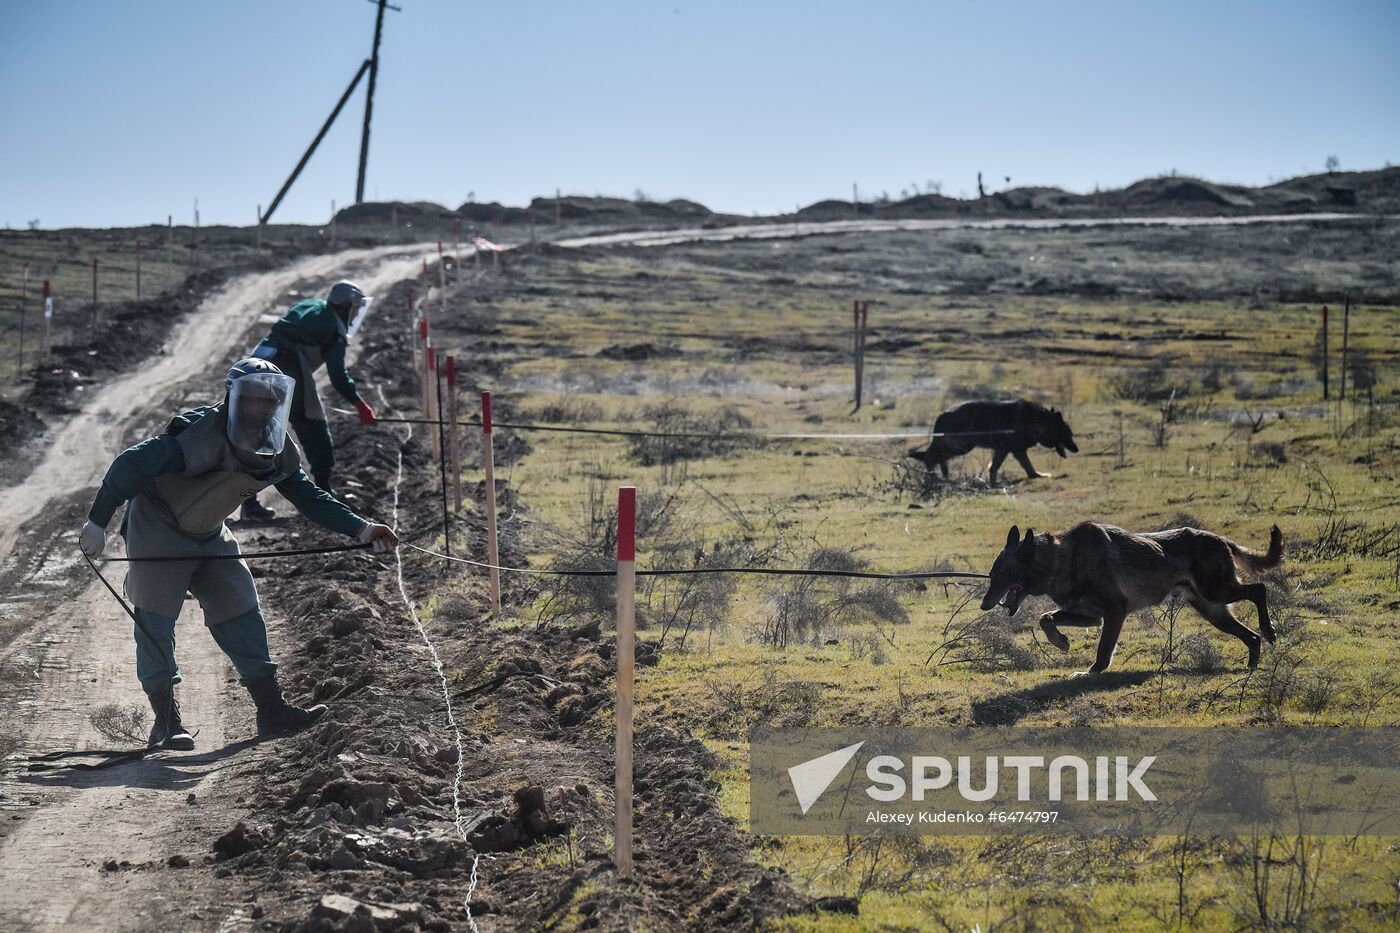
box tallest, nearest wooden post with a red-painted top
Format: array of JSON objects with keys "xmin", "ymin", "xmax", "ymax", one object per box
[{"xmin": 613, "ymin": 486, "xmax": 637, "ymax": 878}]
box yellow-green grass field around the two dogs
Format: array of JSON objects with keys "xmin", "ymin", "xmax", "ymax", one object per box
[{"xmin": 417, "ymin": 221, "xmax": 1400, "ymax": 930}]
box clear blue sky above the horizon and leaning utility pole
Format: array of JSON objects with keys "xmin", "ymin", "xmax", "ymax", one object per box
[{"xmin": 0, "ymin": 0, "xmax": 1400, "ymax": 228}]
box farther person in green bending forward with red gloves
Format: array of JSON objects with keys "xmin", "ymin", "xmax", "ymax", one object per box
[{"xmin": 241, "ymin": 282, "xmax": 374, "ymax": 521}]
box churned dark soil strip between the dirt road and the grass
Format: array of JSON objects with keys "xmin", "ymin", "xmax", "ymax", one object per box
[{"xmin": 207, "ymin": 267, "xmax": 806, "ymax": 930}]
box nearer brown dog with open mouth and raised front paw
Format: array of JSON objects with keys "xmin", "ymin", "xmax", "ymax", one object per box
[{"xmin": 981, "ymin": 521, "xmax": 1284, "ymax": 674}]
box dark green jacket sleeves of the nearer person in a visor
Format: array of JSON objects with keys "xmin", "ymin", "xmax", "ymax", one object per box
[{"xmin": 88, "ymin": 406, "xmax": 368, "ymax": 538}]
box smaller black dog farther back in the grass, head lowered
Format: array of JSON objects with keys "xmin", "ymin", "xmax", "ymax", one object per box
[{"xmin": 909, "ymin": 398, "xmax": 1079, "ymax": 482}]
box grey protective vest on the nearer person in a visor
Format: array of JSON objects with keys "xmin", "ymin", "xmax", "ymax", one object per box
[{"xmin": 150, "ymin": 406, "xmax": 301, "ymax": 537}]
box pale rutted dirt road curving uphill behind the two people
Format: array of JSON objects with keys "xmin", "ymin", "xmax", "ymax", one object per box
[{"xmin": 0, "ymin": 236, "xmax": 470, "ymax": 930}]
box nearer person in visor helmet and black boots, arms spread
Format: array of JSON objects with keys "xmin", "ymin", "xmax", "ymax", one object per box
[{"xmin": 80, "ymin": 359, "xmax": 399, "ymax": 749}]
